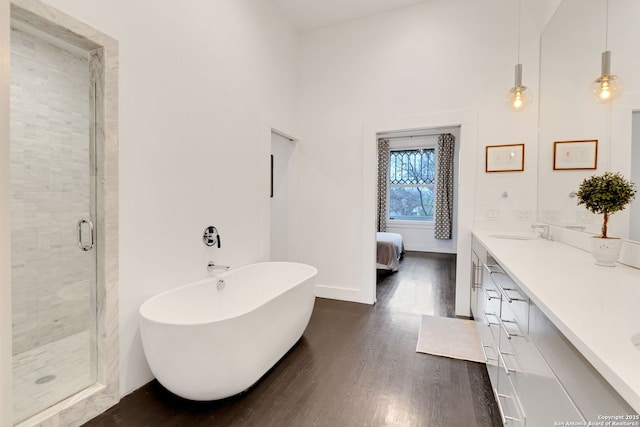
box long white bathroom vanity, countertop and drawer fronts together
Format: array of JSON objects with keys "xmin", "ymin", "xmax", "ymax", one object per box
[{"xmin": 473, "ymin": 232, "xmax": 640, "ymax": 427}]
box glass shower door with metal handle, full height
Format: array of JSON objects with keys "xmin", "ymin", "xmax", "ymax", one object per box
[{"xmin": 10, "ymin": 23, "xmax": 97, "ymax": 423}]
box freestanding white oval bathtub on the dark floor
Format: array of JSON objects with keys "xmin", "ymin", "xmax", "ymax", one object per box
[{"xmin": 140, "ymin": 262, "xmax": 318, "ymax": 400}]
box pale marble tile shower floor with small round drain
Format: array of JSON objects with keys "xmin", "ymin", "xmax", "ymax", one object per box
[{"xmin": 13, "ymin": 331, "xmax": 94, "ymax": 424}]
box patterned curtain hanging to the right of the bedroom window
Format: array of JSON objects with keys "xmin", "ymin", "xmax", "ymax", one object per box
[{"xmin": 435, "ymin": 133, "xmax": 456, "ymax": 240}]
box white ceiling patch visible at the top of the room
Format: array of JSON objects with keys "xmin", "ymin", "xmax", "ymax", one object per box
[{"xmin": 274, "ymin": 0, "xmax": 425, "ymax": 31}]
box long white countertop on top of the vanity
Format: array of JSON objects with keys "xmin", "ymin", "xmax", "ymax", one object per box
[{"xmin": 473, "ymin": 231, "xmax": 640, "ymax": 413}]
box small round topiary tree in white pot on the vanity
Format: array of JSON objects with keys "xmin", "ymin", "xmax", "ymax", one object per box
[{"xmin": 576, "ymin": 172, "xmax": 636, "ymax": 267}]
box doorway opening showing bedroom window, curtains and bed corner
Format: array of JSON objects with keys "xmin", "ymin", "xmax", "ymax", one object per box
[{"xmin": 375, "ymin": 126, "xmax": 460, "ymax": 311}]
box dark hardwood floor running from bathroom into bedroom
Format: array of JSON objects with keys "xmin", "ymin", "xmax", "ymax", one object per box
[{"xmin": 85, "ymin": 252, "xmax": 501, "ymax": 427}]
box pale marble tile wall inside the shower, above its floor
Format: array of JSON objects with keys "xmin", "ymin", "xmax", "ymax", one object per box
[{"xmin": 10, "ymin": 25, "xmax": 95, "ymax": 354}]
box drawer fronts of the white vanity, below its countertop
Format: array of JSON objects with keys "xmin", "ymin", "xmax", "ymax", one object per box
[{"xmin": 472, "ymin": 239, "xmax": 616, "ymax": 427}]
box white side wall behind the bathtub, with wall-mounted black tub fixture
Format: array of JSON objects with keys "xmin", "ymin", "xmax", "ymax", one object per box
[{"xmin": 29, "ymin": 0, "xmax": 297, "ymax": 394}]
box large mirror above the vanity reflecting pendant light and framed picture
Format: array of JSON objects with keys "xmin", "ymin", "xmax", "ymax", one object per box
[{"xmin": 537, "ymin": 0, "xmax": 640, "ymax": 242}]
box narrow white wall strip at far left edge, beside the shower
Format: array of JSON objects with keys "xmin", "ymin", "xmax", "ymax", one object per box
[{"xmin": 0, "ymin": 0, "xmax": 12, "ymax": 426}]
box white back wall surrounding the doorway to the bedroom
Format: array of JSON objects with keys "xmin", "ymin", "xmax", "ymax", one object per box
[{"xmin": 299, "ymin": 0, "xmax": 538, "ymax": 314}]
